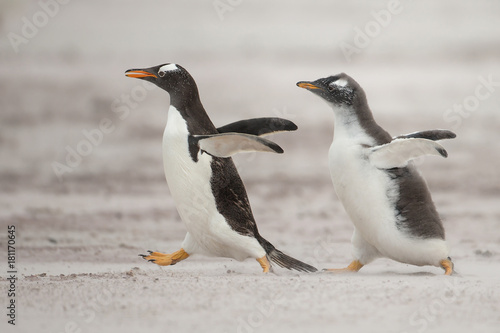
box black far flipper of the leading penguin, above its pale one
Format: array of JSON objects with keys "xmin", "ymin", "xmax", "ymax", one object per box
[{"xmin": 217, "ymin": 117, "xmax": 297, "ymax": 136}]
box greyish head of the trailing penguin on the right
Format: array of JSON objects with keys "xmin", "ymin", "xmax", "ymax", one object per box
[{"xmin": 297, "ymin": 73, "xmax": 366, "ymax": 106}]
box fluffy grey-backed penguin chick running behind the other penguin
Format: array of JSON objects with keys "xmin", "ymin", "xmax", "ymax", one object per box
[{"xmin": 297, "ymin": 73, "xmax": 455, "ymax": 275}]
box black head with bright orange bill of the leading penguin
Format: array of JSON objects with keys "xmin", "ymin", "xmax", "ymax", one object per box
[{"xmin": 125, "ymin": 63, "xmax": 199, "ymax": 104}]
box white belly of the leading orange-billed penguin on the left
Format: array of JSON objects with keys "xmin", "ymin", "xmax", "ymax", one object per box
[{"xmin": 163, "ymin": 106, "xmax": 265, "ymax": 260}]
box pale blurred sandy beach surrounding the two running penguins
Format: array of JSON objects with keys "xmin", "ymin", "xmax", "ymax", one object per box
[{"xmin": 0, "ymin": 0, "xmax": 500, "ymax": 333}]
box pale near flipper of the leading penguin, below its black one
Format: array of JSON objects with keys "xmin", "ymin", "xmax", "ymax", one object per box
[{"xmin": 193, "ymin": 133, "xmax": 283, "ymax": 157}]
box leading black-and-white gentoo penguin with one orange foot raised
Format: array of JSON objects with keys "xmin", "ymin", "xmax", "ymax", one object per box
[{"xmin": 125, "ymin": 63, "xmax": 317, "ymax": 272}]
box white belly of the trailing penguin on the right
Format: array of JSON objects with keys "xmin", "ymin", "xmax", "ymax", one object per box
[{"xmin": 329, "ymin": 138, "xmax": 448, "ymax": 265}]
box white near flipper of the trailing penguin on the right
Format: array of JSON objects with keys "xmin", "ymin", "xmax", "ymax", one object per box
[{"xmin": 369, "ymin": 138, "xmax": 448, "ymax": 169}]
